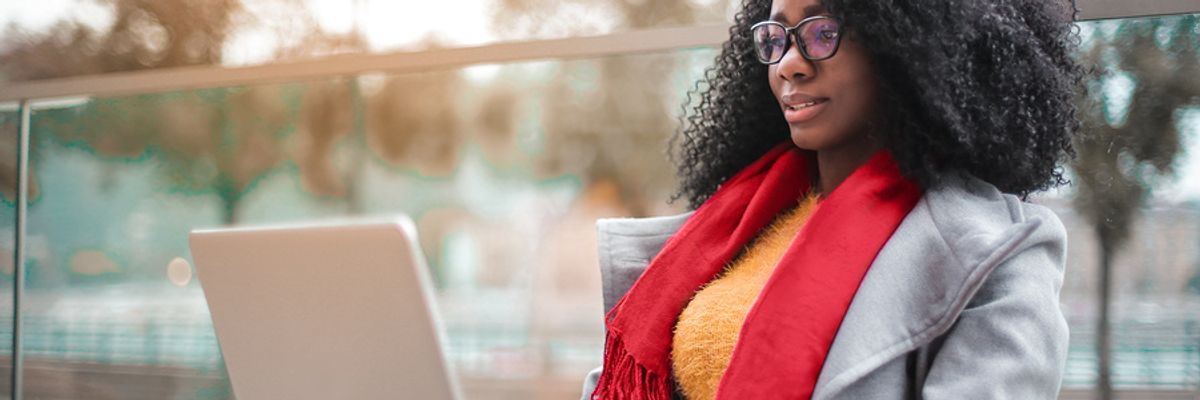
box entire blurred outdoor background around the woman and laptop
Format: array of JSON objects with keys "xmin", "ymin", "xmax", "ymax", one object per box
[{"xmin": 0, "ymin": 0, "xmax": 1200, "ymax": 399}]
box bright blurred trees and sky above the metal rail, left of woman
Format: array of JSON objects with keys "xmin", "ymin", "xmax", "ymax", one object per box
[{"xmin": 0, "ymin": 0, "xmax": 734, "ymax": 80}]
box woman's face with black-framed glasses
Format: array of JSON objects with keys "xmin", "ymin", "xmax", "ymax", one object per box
[{"xmin": 767, "ymin": 0, "xmax": 878, "ymax": 151}]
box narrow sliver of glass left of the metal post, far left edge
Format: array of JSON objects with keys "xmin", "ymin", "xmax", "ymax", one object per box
[{"xmin": 0, "ymin": 103, "xmax": 19, "ymax": 399}]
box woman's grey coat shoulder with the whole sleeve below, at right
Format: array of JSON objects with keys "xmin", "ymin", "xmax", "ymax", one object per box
[{"xmin": 923, "ymin": 178, "xmax": 1069, "ymax": 399}]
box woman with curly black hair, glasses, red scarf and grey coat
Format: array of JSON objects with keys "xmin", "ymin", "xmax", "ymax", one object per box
[{"xmin": 583, "ymin": 0, "xmax": 1081, "ymax": 399}]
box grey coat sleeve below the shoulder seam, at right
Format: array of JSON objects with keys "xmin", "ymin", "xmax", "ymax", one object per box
[{"xmin": 922, "ymin": 209, "xmax": 1068, "ymax": 400}]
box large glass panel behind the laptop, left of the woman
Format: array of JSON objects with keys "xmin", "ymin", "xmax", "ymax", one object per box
[{"xmin": 25, "ymin": 45, "xmax": 715, "ymax": 399}]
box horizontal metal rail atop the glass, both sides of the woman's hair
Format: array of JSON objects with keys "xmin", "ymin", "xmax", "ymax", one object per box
[{"xmin": 0, "ymin": 0, "xmax": 1200, "ymax": 103}]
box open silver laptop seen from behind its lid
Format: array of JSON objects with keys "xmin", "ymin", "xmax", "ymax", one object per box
[{"xmin": 190, "ymin": 216, "xmax": 462, "ymax": 400}]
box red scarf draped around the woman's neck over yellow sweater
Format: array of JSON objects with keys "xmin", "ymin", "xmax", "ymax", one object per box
[{"xmin": 593, "ymin": 141, "xmax": 922, "ymax": 400}]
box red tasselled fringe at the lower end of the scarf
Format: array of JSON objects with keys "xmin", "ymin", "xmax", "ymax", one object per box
[{"xmin": 592, "ymin": 327, "xmax": 673, "ymax": 400}]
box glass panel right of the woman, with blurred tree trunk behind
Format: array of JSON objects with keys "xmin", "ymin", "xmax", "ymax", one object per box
[{"xmin": 1043, "ymin": 14, "xmax": 1200, "ymax": 396}]
